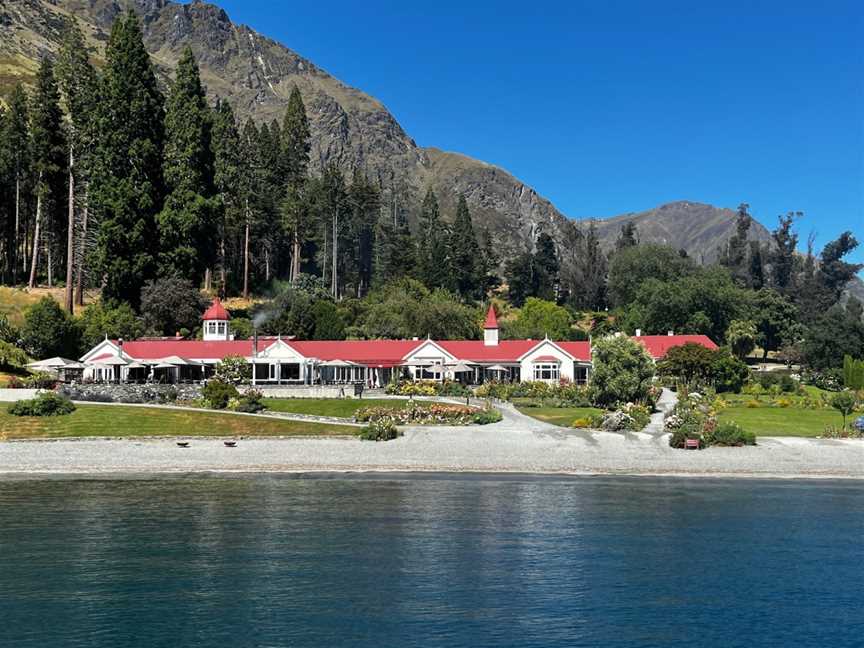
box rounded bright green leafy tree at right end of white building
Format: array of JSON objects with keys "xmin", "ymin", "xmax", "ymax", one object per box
[{"xmin": 589, "ymin": 335, "xmax": 654, "ymax": 407}]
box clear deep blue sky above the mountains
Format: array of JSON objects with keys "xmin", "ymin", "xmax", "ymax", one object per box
[{"xmin": 206, "ymin": 0, "xmax": 864, "ymax": 262}]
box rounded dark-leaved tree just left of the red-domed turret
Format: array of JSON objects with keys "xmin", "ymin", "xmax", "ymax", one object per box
[{"xmin": 141, "ymin": 276, "xmax": 208, "ymax": 336}]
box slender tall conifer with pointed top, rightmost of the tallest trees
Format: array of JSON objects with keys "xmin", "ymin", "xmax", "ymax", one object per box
[{"xmin": 282, "ymin": 85, "xmax": 311, "ymax": 283}]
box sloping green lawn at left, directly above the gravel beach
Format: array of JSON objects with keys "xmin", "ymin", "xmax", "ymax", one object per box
[{"xmin": 0, "ymin": 404, "xmax": 359, "ymax": 439}]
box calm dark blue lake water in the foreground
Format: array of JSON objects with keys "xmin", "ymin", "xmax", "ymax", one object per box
[{"xmin": 0, "ymin": 476, "xmax": 864, "ymax": 648}]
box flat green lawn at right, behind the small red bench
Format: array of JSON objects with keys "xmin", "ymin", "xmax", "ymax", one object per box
[{"xmin": 717, "ymin": 407, "xmax": 856, "ymax": 437}]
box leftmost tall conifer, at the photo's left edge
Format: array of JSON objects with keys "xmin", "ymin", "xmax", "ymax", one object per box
[{"xmin": 0, "ymin": 83, "xmax": 32, "ymax": 283}]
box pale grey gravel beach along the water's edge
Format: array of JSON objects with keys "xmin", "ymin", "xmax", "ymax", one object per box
[{"xmin": 0, "ymin": 408, "xmax": 864, "ymax": 479}]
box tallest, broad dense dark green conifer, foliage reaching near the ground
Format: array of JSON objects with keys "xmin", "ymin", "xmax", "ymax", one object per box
[{"xmin": 90, "ymin": 12, "xmax": 164, "ymax": 306}]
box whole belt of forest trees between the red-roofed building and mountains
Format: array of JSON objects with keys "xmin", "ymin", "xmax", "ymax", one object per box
[{"xmin": 0, "ymin": 12, "xmax": 864, "ymax": 369}]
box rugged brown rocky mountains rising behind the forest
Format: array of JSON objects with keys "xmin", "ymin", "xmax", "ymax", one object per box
[{"xmin": 0, "ymin": 0, "xmax": 864, "ymax": 293}]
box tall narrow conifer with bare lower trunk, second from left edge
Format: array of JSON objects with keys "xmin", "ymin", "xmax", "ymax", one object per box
[{"xmin": 28, "ymin": 58, "xmax": 66, "ymax": 288}]
